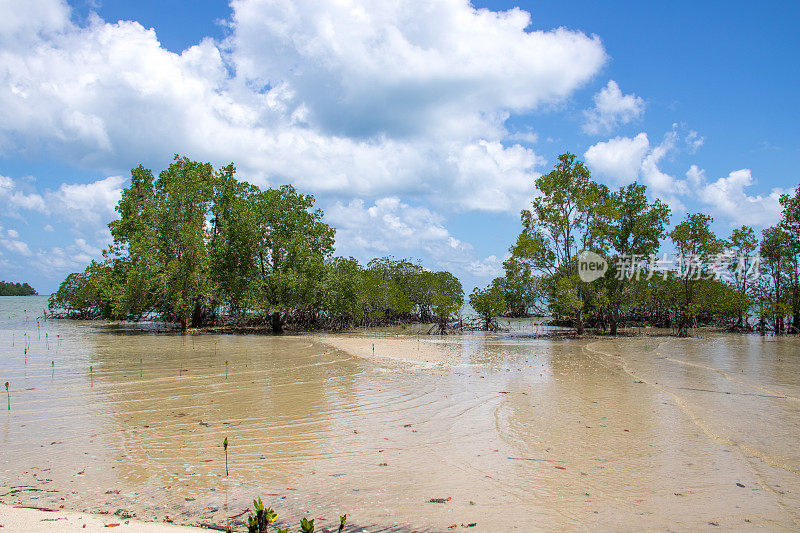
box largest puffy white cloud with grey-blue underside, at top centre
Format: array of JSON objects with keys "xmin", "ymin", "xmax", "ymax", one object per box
[{"xmin": 228, "ymin": 0, "xmax": 606, "ymax": 139}]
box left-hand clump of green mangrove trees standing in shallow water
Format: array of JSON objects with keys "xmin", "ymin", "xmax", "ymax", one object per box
[{"xmin": 49, "ymin": 156, "xmax": 463, "ymax": 332}]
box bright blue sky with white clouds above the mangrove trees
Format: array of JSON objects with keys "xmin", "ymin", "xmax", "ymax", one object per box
[{"xmin": 0, "ymin": 0, "xmax": 800, "ymax": 293}]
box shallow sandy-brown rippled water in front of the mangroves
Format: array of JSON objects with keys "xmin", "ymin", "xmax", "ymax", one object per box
[{"xmin": 0, "ymin": 297, "xmax": 800, "ymax": 532}]
